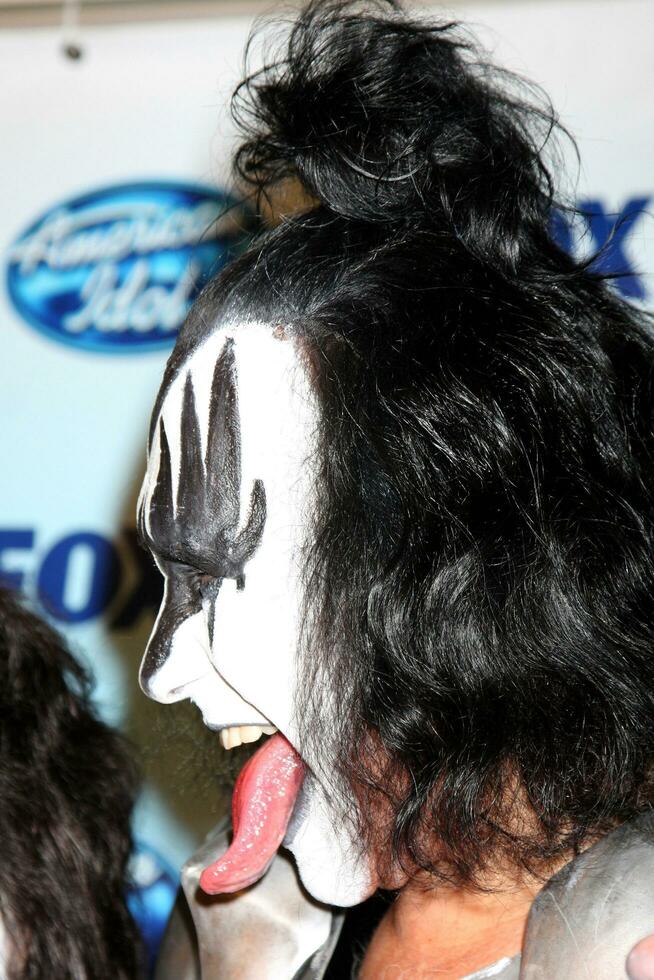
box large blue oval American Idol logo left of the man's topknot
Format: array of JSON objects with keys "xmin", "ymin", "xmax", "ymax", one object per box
[{"xmin": 7, "ymin": 182, "xmax": 252, "ymax": 353}]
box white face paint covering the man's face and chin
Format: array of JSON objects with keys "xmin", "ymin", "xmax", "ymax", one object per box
[{"xmin": 139, "ymin": 324, "xmax": 373, "ymax": 905}]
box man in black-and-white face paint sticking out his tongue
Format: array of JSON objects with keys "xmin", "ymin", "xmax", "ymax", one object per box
[{"xmin": 146, "ymin": 0, "xmax": 654, "ymax": 980}]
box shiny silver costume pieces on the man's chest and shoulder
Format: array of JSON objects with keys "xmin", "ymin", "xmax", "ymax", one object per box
[{"xmin": 156, "ymin": 812, "xmax": 654, "ymax": 980}]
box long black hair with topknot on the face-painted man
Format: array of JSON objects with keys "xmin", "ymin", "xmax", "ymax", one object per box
[{"xmin": 161, "ymin": 0, "xmax": 654, "ymax": 884}]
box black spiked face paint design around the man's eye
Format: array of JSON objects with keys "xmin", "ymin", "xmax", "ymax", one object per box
[{"xmin": 139, "ymin": 339, "xmax": 266, "ymax": 685}]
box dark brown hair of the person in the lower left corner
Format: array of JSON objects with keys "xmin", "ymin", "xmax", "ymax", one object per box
[{"xmin": 0, "ymin": 589, "xmax": 142, "ymax": 980}]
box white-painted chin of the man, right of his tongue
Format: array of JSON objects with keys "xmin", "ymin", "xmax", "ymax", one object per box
[{"xmin": 284, "ymin": 775, "xmax": 377, "ymax": 908}]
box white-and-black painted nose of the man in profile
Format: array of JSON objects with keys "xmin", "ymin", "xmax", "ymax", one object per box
[{"xmin": 139, "ymin": 613, "xmax": 213, "ymax": 704}]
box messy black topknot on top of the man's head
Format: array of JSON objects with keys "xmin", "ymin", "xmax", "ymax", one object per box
[{"xmin": 233, "ymin": 0, "xmax": 555, "ymax": 272}]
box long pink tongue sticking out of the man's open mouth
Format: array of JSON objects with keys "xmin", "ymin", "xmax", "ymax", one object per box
[{"xmin": 200, "ymin": 732, "xmax": 304, "ymax": 895}]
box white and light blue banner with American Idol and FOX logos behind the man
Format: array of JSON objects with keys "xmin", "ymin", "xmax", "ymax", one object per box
[{"xmin": 0, "ymin": 0, "xmax": 654, "ymax": 964}]
